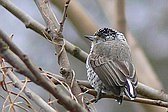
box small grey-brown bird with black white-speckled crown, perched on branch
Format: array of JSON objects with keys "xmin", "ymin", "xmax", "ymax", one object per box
[{"xmin": 85, "ymin": 28, "xmax": 138, "ymax": 104}]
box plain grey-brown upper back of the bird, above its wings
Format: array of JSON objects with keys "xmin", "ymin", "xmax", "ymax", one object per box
[{"xmin": 90, "ymin": 40, "xmax": 132, "ymax": 62}]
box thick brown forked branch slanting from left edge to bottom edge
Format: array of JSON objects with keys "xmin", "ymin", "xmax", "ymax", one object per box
[{"xmin": 0, "ymin": 30, "xmax": 85, "ymax": 112}]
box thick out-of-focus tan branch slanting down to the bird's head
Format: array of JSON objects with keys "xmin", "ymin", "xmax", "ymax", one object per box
[{"xmin": 51, "ymin": 0, "xmax": 97, "ymax": 36}]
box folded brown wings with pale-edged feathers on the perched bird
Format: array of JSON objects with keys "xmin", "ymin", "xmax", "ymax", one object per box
[{"xmin": 89, "ymin": 55, "xmax": 137, "ymax": 86}]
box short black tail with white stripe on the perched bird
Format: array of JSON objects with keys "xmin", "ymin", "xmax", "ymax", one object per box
[{"xmin": 124, "ymin": 79, "xmax": 137, "ymax": 100}]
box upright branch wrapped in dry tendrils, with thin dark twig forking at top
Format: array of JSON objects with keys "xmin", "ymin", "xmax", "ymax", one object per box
[{"xmin": 34, "ymin": 0, "xmax": 87, "ymax": 107}]
